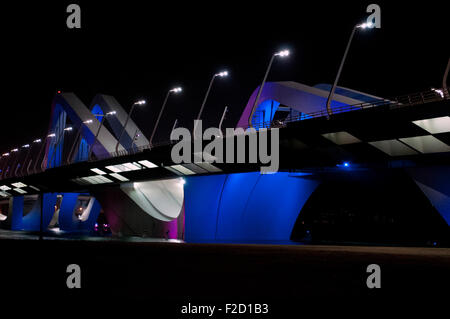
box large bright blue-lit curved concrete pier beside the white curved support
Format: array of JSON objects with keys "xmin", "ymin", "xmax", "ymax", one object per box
[{"xmin": 185, "ymin": 172, "xmax": 319, "ymax": 242}]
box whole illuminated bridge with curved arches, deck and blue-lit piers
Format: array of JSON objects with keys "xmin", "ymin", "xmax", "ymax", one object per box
[{"xmin": 0, "ymin": 82, "xmax": 450, "ymax": 242}]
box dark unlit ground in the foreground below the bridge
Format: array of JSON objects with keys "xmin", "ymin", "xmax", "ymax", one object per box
[{"xmin": 0, "ymin": 237, "xmax": 450, "ymax": 318}]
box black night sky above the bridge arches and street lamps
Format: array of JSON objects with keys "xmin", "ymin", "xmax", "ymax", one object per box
[{"xmin": 0, "ymin": 0, "xmax": 450, "ymax": 152}]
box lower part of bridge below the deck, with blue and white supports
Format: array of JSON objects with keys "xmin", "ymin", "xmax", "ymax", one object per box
[{"xmin": 0, "ymin": 166, "xmax": 450, "ymax": 243}]
